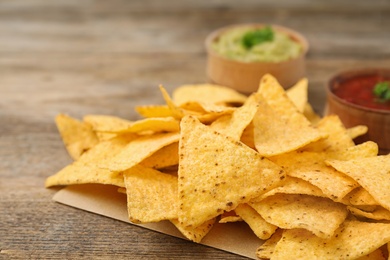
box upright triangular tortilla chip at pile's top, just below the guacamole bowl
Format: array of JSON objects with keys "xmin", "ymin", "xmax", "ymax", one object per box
[{"xmin": 253, "ymin": 89, "xmax": 323, "ymax": 156}]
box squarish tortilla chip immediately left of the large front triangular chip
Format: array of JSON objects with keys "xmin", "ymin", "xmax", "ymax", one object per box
[{"xmin": 123, "ymin": 165, "xmax": 178, "ymax": 223}]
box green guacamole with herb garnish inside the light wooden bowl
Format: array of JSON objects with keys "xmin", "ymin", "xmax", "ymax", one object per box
[{"xmin": 212, "ymin": 27, "xmax": 303, "ymax": 62}]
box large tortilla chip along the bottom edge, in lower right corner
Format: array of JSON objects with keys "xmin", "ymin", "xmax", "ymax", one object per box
[{"xmin": 272, "ymin": 220, "xmax": 390, "ymax": 260}]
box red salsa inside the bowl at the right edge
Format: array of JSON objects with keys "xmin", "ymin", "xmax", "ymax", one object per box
[{"xmin": 332, "ymin": 75, "xmax": 390, "ymax": 110}]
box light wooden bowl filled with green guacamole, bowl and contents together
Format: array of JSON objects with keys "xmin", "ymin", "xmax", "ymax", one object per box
[{"xmin": 206, "ymin": 24, "xmax": 308, "ymax": 94}]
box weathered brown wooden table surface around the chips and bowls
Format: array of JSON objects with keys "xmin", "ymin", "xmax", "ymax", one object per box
[{"xmin": 0, "ymin": 0, "xmax": 390, "ymax": 259}]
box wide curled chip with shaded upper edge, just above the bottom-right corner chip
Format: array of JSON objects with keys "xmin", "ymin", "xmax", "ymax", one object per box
[{"xmin": 250, "ymin": 194, "xmax": 347, "ymax": 238}]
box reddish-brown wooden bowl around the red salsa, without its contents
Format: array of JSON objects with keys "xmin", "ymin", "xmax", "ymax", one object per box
[{"xmin": 325, "ymin": 69, "xmax": 390, "ymax": 154}]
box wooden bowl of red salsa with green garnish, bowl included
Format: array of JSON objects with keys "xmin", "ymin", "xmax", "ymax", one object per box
[{"xmin": 325, "ymin": 68, "xmax": 390, "ymax": 154}]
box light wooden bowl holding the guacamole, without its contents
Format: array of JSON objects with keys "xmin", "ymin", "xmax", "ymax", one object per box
[{"xmin": 206, "ymin": 24, "xmax": 308, "ymax": 94}]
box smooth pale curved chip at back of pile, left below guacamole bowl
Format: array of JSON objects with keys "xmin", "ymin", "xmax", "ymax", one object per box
[{"xmin": 172, "ymin": 84, "xmax": 246, "ymax": 106}]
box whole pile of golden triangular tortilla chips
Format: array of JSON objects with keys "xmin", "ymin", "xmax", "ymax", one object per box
[{"xmin": 46, "ymin": 75, "xmax": 390, "ymax": 259}]
